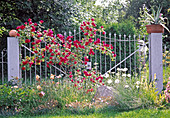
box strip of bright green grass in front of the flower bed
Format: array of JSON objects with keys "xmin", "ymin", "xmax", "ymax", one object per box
[{"xmin": 9, "ymin": 109, "xmax": 170, "ymax": 118}]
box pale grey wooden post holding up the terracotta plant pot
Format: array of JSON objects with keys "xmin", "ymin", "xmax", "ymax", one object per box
[{"xmin": 149, "ymin": 33, "xmax": 163, "ymax": 93}]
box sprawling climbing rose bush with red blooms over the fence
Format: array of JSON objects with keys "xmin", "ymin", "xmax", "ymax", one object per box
[{"xmin": 16, "ymin": 18, "xmax": 116, "ymax": 93}]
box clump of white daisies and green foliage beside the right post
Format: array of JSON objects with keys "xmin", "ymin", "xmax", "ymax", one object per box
[{"xmin": 105, "ymin": 69, "xmax": 166, "ymax": 110}]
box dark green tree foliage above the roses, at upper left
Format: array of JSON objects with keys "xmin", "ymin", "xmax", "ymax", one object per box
[{"xmin": 0, "ymin": 0, "xmax": 77, "ymax": 32}]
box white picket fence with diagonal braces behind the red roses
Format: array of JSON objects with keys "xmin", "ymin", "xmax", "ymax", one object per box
[{"xmin": 0, "ymin": 30, "xmax": 169, "ymax": 91}]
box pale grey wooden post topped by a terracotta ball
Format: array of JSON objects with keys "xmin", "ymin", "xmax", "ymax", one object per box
[{"xmin": 7, "ymin": 37, "xmax": 20, "ymax": 81}]
